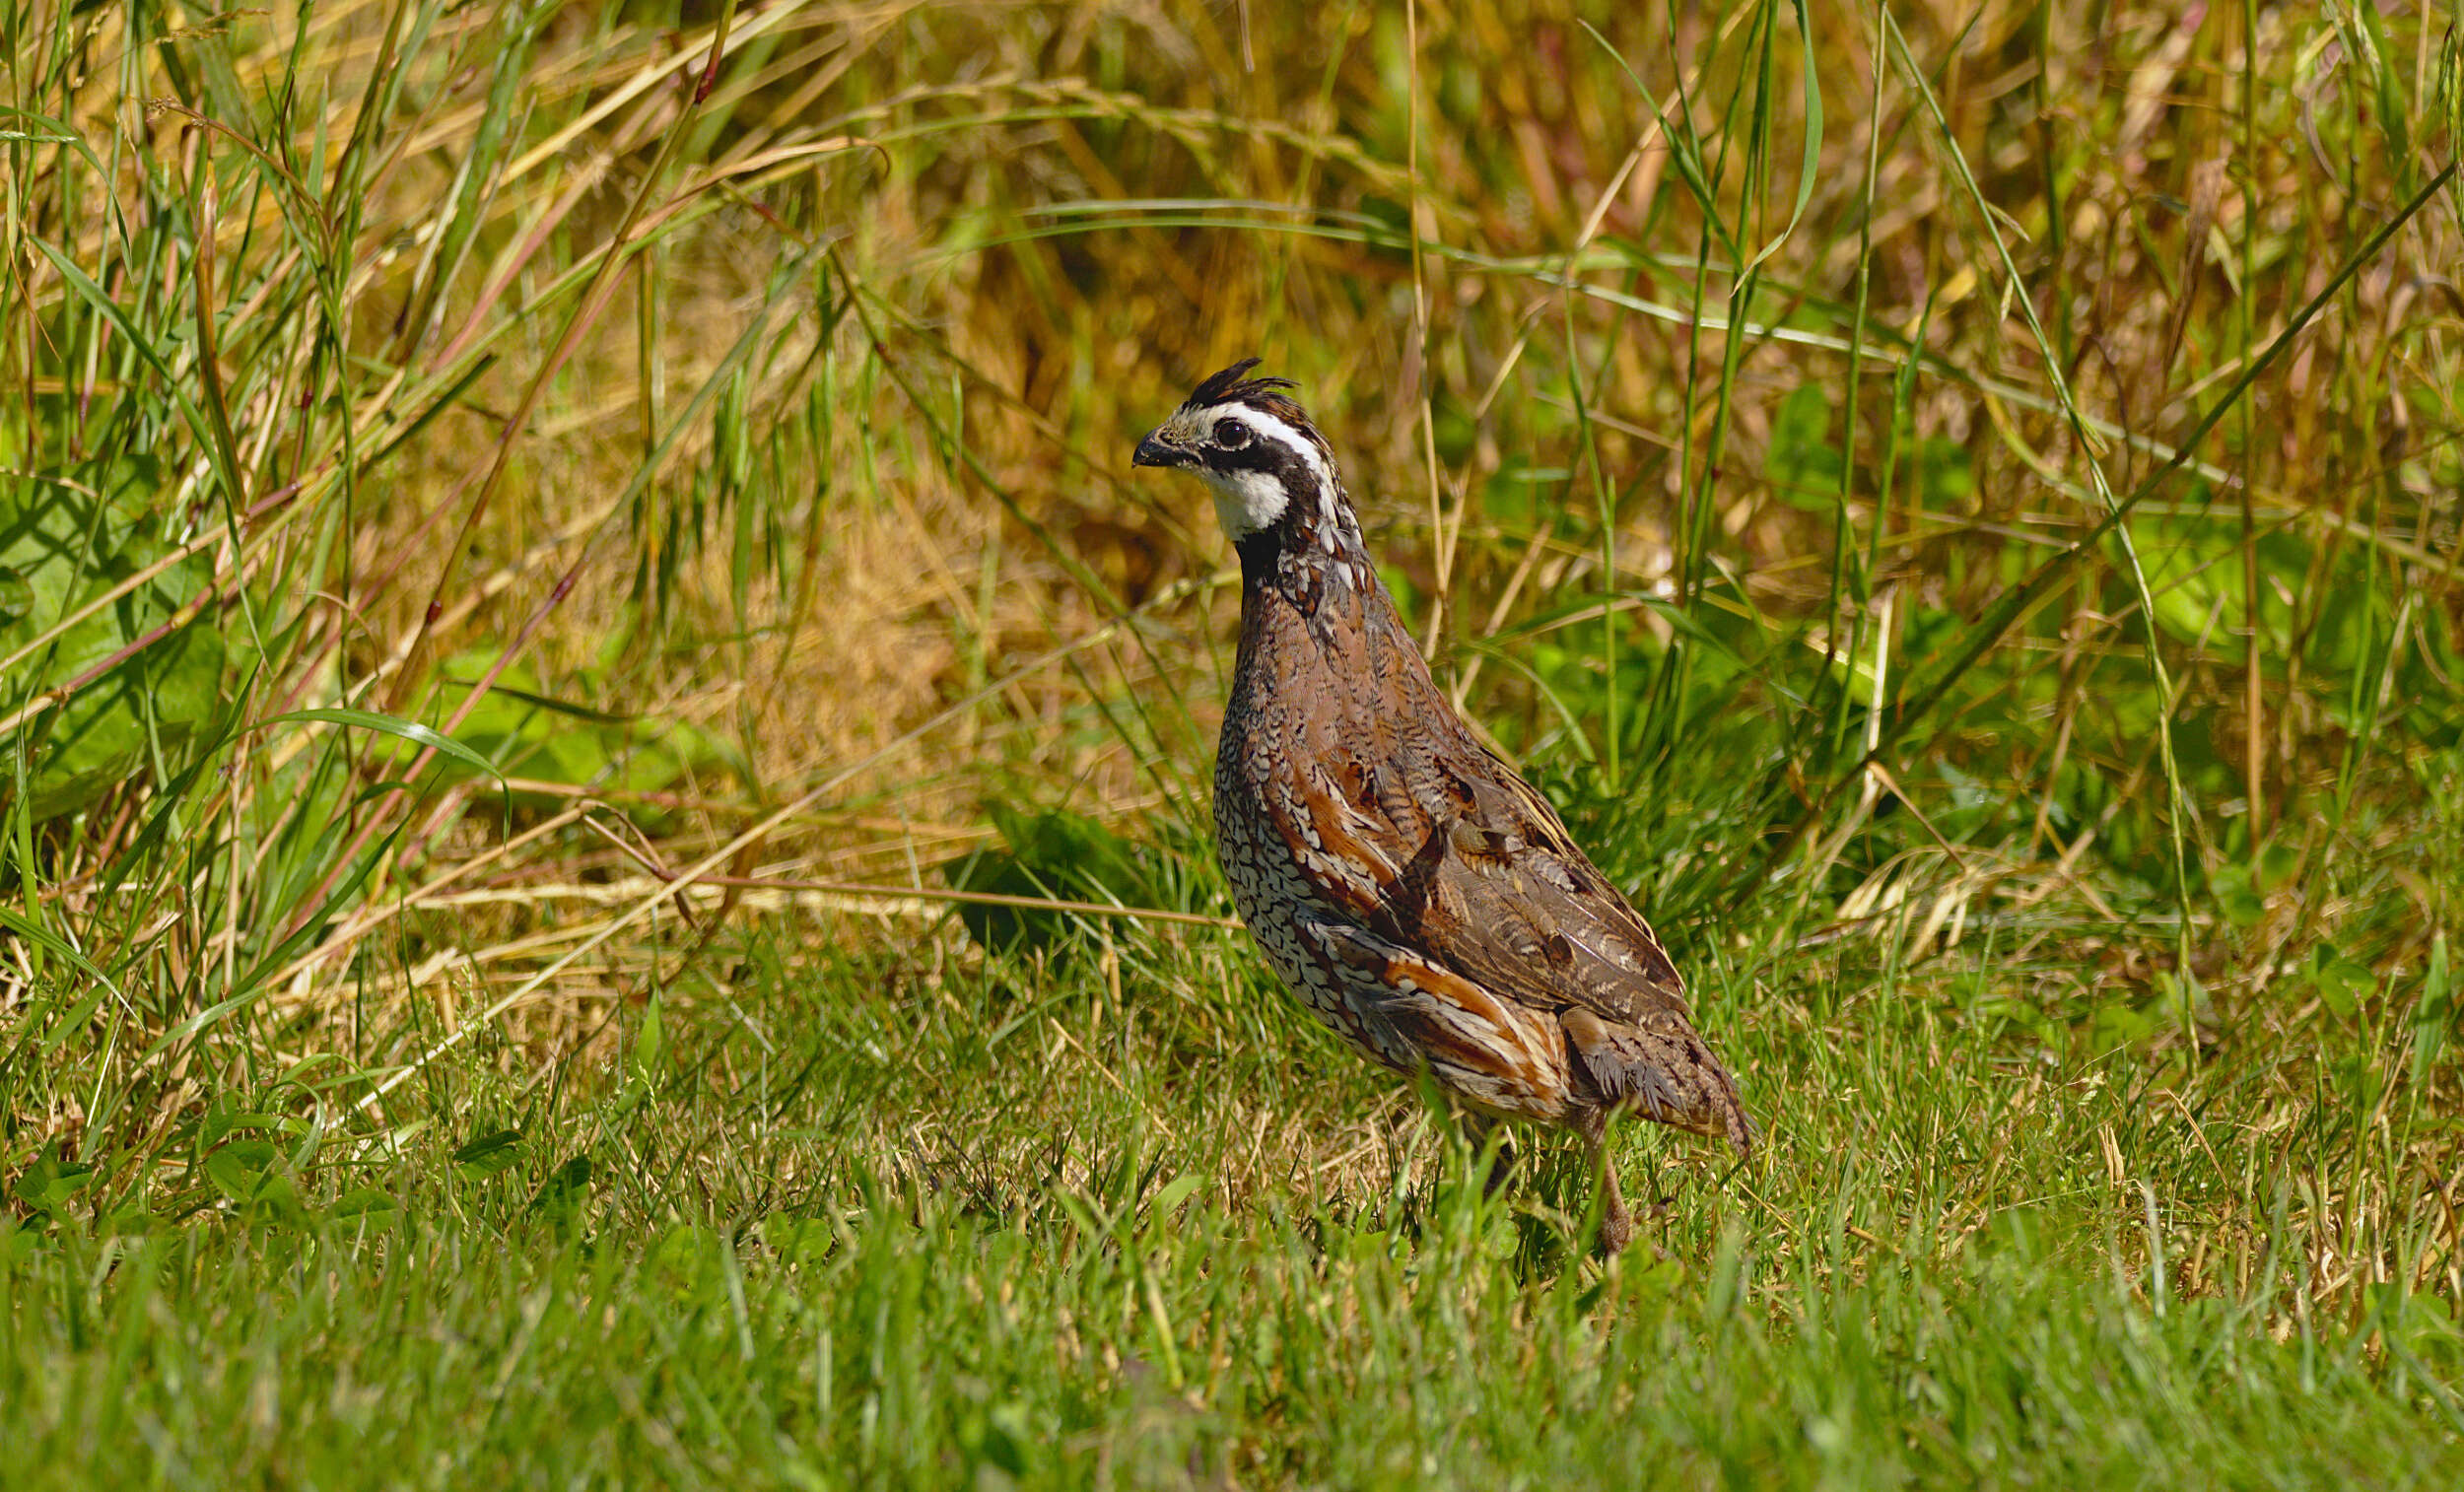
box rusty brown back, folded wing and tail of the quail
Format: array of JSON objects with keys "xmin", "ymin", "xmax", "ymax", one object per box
[{"xmin": 1252, "ymin": 578, "xmax": 1752, "ymax": 1152}]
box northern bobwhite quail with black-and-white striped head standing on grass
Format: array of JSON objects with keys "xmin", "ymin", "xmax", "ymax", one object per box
[{"xmin": 1131, "ymin": 357, "xmax": 1752, "ymax": 1254}]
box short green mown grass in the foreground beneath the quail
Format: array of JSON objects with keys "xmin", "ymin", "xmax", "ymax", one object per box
[{"xmin": 0, "ymin": 933, "xmax": 2464, "ymax": 1487}]
